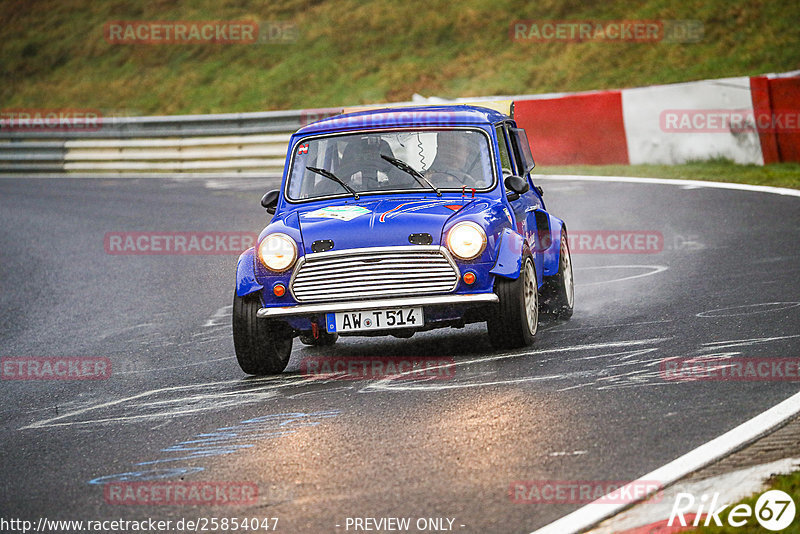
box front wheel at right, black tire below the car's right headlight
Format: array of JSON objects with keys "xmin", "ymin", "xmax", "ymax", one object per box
[{"xmin": 486, "ymin": 249, "xmax": 539, "ymax": 349}]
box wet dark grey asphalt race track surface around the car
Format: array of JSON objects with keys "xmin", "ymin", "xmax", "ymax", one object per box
[{"xmin": 0, "ymin": 179, "xmax": 800, "ymax": 533}]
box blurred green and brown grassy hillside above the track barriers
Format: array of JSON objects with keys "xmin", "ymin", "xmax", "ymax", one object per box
[{"xmin": 0, "ymin": 0, "xmax": 800, "ymax": 115}]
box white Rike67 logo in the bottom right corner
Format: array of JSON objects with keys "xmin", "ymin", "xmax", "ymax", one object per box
[{"xmin": 667, "ymin": 490, "xmax": 797, "ymax": 532}]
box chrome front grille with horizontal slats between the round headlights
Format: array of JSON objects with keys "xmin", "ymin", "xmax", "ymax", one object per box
[{"xmin": 290, "ymin": 246, "xmax": 460, "ymax": 302}]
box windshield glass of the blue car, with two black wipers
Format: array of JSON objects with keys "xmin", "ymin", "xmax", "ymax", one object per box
[{"xmin": 286, "ymin": 129, "xmax": 494, "ymax": 200}]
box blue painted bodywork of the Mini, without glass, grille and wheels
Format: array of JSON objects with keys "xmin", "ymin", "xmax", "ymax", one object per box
[{"xmin": 236, "ymin": 106, "xmax": 564, "ymax": 330}]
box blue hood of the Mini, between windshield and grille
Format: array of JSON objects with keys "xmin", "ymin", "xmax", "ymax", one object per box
[{"xmin": 299, "ymin": 198, "xmax": 472, "ymax": 254}]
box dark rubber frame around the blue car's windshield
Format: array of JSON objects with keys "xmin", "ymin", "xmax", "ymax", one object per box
[{"xmin": 282, "ymin": 126, "xmax": 498, "ymax": 204}]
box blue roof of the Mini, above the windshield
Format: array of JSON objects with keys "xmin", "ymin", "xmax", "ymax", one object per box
[{"xmin": 297, "ymin": 105, "xmax": 508, "ymax": 134}]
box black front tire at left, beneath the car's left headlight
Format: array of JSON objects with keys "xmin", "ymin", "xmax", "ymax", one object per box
[{"xmin": 233, "ymin": 294, "xmax": 293, "ymax": 375}]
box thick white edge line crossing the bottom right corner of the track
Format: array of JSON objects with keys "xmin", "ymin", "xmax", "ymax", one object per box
[{"xmin": 535, "ymin": 393, "xmax": 800, "ymax": 534}]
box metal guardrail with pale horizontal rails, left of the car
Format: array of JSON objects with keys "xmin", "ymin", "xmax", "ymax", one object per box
[{"xmin": 0, "ymin": 110, "xmax": 324, "ymax": 177}]
